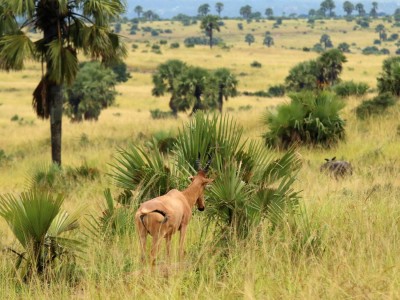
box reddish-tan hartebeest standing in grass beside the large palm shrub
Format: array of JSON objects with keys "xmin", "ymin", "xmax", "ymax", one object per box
[{"xmin": 135, "ymin": 158, "xmax": 213, "ymax": 265}]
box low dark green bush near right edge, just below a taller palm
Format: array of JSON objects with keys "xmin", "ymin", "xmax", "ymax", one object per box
[{"xmin": 356, "ymin": 93, "xmax": 396, "ymax": 119}]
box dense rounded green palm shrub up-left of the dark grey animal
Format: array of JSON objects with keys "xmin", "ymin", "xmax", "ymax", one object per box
[{"xmin": 263, "ymin": 91, "xmax": 345, "ymax": 149}]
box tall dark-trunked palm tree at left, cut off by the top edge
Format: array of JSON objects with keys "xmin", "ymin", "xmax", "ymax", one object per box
[{"xmin": 0, "ymin": 0, "xmax": 125, "ymax": 165}]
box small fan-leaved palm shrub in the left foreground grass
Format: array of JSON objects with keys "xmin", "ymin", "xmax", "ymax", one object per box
[{"xmin": 0, "ymin": 191, "xmax": 84, "ymax": 280}]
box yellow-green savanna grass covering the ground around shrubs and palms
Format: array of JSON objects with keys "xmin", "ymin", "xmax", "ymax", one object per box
[{"xmin": 0, "ymin": 20, "xmax": 400, "ymax": 299}]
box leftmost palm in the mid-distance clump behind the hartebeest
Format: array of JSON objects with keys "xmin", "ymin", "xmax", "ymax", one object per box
[{"xmin": 152, "ymin": 59, "xmax": 187, "ymax": 116}]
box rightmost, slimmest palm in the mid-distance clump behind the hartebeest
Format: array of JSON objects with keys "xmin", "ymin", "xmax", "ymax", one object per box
[{"xmin": 214, "ymin": 68, "xmax": 239, "ymax": 113}]
